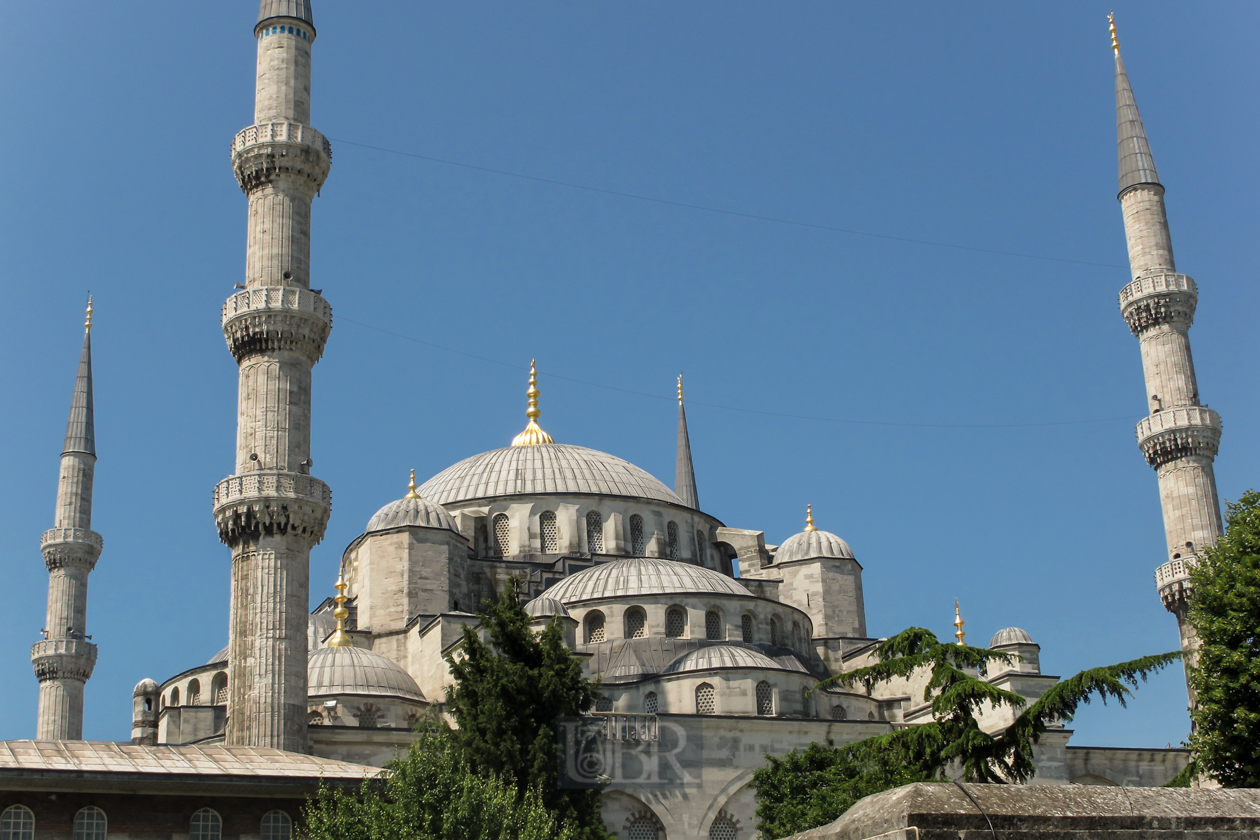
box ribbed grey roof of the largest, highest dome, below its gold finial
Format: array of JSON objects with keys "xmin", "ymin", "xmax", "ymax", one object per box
[{"xmin": 420, "ymin": 443, "xmax": 685, "ymax": 506}]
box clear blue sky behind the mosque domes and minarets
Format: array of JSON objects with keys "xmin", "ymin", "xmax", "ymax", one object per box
[{"xmin": 0, "ymin": 0, "xmax": 1260, "ymax": 747}]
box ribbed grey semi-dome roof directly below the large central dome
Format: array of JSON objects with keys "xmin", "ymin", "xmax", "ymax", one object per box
[{"xmin": 543, "ymin": 557, "xmax": 752, "ymax": 604}]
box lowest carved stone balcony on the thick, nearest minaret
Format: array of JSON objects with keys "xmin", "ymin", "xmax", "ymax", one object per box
[{"xmin": 214, "ymin": 472, "xmax": 333, "ymax": 548}]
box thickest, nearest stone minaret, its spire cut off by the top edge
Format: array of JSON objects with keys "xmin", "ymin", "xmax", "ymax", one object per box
[{"xmin": 214, "ymin": 0, "xmax": 333, "ymax": 752}]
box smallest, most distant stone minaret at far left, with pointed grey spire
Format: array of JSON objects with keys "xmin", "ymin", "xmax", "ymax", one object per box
[{"xmin": 30, "ymin": 298, "xmax": 102, "ymax": 741}]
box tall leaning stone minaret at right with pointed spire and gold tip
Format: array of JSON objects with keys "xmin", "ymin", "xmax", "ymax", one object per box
[{"xmin": 1110, "ymin": 19, "xmax": 1221, "ymax": 701}]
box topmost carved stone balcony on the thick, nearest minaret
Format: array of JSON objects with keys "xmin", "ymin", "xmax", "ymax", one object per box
[{"xmin": 232, "ymin": 122, "xmax": 333, "ymax": 194}]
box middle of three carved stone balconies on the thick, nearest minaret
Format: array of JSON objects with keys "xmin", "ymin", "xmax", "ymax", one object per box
[{"xmin": 223, "ymin": 286, "xmax": 333, "ymax": 364}]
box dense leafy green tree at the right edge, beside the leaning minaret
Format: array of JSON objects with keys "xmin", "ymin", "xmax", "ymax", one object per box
[{"xmin": 1187, "ymin": 490, "xmax": 1260, "ymax": 787}]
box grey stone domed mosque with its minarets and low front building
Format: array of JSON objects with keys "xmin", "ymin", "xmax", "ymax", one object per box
[{"xmin": 0, "ymin": 0, "xmax": 1220, "ymax": 840}]
